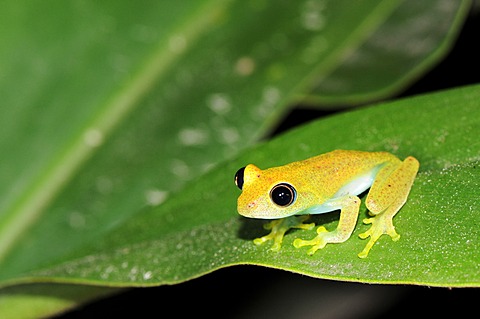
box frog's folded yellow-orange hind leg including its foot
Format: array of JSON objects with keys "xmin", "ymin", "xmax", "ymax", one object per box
[{"xmin": 358, "ymin": 157, "xmax": 419, "ymax": 258}]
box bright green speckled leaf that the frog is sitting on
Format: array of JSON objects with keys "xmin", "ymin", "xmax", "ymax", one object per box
[{"xmin": 4, "ymin": 85, "xmax": 480, "ymax": 287}]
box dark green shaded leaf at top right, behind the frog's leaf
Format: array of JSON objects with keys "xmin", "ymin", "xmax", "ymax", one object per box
[{"xmin": 303, "ymin": 1, "xmax": 470, "ymax": 105}]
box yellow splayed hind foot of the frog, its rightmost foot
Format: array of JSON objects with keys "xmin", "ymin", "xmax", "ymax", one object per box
[{"xmin": 358, "ymin": 214, "xmax": 400, "ymax": 258}]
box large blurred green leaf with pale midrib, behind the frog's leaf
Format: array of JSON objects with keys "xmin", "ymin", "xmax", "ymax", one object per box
[{"xmin": 0, "ymin": 0, "xmax": 468, "ymax": 313}]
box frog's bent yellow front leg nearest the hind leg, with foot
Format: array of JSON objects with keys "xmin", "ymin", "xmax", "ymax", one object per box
[{"xmin": 293, "ymin": 195, "xmax": 360, "ymax": 255}]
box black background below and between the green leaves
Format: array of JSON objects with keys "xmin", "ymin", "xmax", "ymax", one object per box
[{"xmin": 58, "ymin": 6, "xmax": 480, "ymax": 319}]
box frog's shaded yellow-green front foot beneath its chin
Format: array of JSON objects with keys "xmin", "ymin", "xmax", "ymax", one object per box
[{"xmin": 253, "ymin": 215, "xmax": 315, "ymax": 251}]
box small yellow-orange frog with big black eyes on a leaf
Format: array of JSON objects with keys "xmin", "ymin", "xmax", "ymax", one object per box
[{"xmin": 234, "ymin": 150, "xmax": 420, "ymax": 258}]
